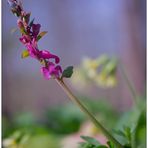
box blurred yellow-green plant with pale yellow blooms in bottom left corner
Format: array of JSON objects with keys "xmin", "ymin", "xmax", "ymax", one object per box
[{"xmin": 3, "ymin": 130, "xmax": 60, "ymax": 148}]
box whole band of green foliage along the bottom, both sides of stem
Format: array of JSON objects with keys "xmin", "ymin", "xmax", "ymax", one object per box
[{"xmin": 2, "ymin": 96, "xmax": 146, "ymax": 148}]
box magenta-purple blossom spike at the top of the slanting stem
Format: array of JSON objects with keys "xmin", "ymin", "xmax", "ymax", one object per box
[{"xmin": 8, "ymin": 0, "xmax": 62, "ymax": 79}]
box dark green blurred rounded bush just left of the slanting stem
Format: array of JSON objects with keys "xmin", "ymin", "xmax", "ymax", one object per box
[{"xmin": 46, "ymin": 104, "xmax": 85, "ymax": 134}]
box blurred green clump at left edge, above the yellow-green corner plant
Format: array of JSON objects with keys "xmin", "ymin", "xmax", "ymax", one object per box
[{"xmin": 2, "ymin": 112, "xmax": 49, "ymax": 138}]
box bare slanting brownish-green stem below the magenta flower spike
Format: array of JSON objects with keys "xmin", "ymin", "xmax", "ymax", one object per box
[{"xmin": 55, "ymin": 78, "xmax": 123, "ymax": 148}]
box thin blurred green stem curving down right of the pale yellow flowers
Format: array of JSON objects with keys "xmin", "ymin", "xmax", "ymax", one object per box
[{"xmin": 120, "ymin": 64, "xmax": 138, "ymax": 104}]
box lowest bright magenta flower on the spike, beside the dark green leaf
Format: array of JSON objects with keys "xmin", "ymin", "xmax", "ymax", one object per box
[{"xmin": 41, "ymin": 62, "xmax": 62, "ymax": 79}]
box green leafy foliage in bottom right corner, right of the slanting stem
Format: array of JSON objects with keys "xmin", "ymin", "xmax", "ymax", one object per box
[{"xmin": 115, "ymin": 98, "xmax": 146, "ymax": 148}]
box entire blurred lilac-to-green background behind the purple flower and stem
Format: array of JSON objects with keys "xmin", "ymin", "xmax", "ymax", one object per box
[{"xmin": 2, "ymin": 0, "xmax": 146, "ymax": 148}]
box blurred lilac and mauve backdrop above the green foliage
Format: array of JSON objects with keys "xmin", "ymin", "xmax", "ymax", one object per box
[{"xmin": 2, "ymin": 0, "xmax": 146, "ymax": 147}]
